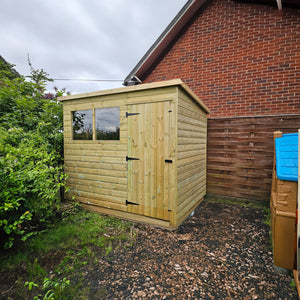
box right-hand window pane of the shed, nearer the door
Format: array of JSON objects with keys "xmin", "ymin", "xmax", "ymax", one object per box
[{"xmin": 96, "ymin": 107, "xmax": 120, "ymax": 140}]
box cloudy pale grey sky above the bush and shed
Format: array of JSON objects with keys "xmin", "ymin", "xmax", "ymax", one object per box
[{"xmin": 0, "ymin": 0, "xmax": 187, "ymax": 94}]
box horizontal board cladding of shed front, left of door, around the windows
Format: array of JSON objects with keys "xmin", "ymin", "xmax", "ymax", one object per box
[{"xmin": 64, "ymin": 100, "xmax": 127, "ymax": 211}]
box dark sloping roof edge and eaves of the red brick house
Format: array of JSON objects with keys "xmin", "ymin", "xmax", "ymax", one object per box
[{"xmin": 123, "ymin": 0, "xmax": 300, "ymax": 86}]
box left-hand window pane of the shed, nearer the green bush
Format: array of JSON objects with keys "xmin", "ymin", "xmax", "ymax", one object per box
[{"xmin": 73, "ymin": 110, "xmax": 93, "ymax": 140}]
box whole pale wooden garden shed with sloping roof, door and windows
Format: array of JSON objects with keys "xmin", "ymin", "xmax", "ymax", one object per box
[{"xmin": 59, "ymin": 80, "xmax": 210, "ymax": 228}]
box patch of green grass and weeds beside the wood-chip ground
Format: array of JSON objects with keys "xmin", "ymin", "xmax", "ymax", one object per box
[{"xmin": 0, "ymin": 204, "xmax": 135, "ymax": 300}]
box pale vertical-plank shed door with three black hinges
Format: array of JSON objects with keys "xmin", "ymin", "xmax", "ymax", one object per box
[{"xmin": 127, "ymin": 101, "xmax": 174, "ymax": 220}]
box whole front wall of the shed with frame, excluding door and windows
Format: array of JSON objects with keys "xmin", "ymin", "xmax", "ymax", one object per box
[{"xmin": 64, "ymin": 86, "xmax": 177, "ymax": 226}]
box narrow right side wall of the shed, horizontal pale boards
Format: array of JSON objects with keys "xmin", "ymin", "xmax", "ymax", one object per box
[{"xmin": 177, "ymin": 91, "xmax": 207, "ymax": 223}]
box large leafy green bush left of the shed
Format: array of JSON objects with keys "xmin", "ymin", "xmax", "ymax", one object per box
[{"xmin": 0, "ymin": 58, "xmax": 66, "ymax": 248}]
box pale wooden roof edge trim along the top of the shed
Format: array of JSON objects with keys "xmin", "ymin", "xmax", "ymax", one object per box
[{"xmin": 58, "ymin": 79, "xmax": 210, "ymax": 114}]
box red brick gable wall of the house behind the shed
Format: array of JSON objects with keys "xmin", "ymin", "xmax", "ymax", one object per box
[{"xmin": 144, "ymin": 0, "xmax": 300, "ymax": 117}]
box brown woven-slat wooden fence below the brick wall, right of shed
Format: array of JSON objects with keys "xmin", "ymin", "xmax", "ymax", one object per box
[{"xmin": 207, "ymin": 115, "xmax": 300, "ymax": 201}]
